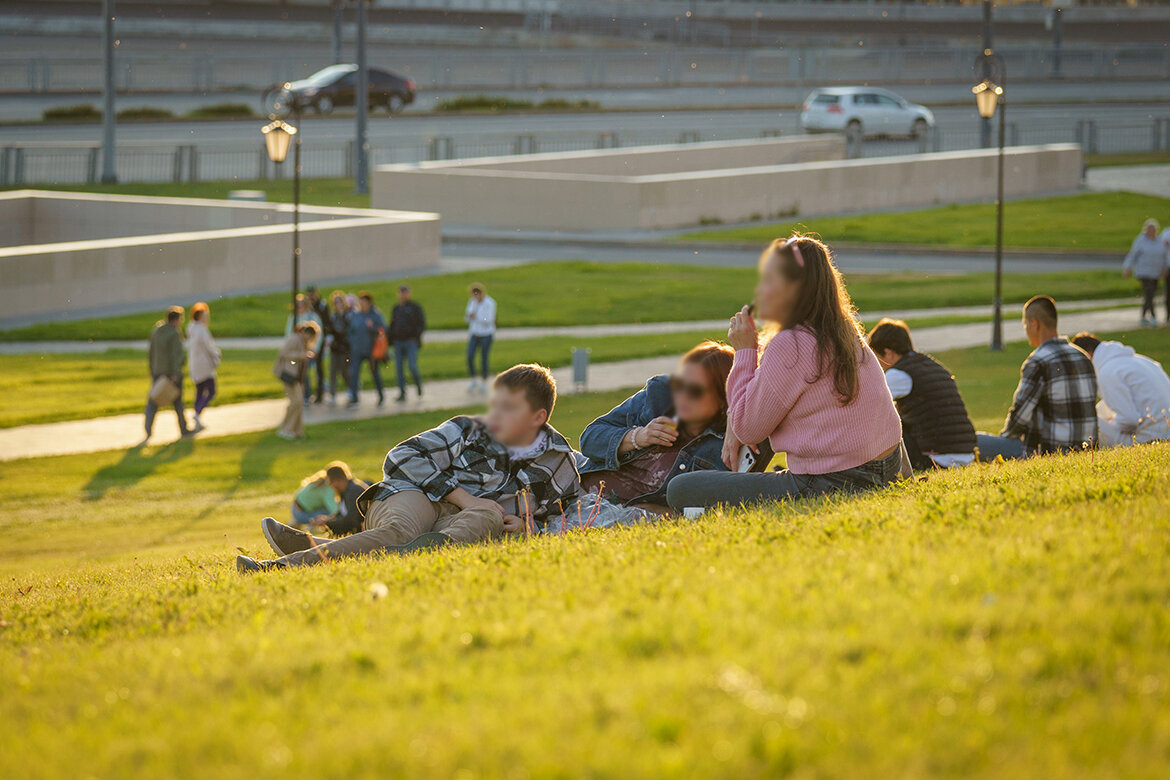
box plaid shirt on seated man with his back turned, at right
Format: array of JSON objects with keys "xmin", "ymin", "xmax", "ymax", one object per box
[{"xmin": 1003, "ymin": 338, "xmax": 1097, "ymax": 453}]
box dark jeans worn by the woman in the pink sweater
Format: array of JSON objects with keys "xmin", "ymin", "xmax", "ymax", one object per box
[{"xmin": 666, "ymin": 448, "xmax": 902, "ymax": 511}]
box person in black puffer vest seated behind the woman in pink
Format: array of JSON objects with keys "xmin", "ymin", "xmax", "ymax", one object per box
[{"xmin": 869, "ymin": 318, "xmax": 976, "ymax": 469}]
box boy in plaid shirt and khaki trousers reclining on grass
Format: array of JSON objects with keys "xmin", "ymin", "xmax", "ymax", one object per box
[{"xmin": 236, "ymin": 365, "xmax": 580, "ymax": 572}]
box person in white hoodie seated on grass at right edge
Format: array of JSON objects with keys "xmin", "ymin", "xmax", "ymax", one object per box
[{"xmin": 1072, "ymin": 333, "xmax": 1170, "ymax": 447}]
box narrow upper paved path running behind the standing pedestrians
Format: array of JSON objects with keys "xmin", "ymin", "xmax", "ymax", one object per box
[{"xmin": 0, "ymin": 298, "xmax": 1138, "ymax": 354}]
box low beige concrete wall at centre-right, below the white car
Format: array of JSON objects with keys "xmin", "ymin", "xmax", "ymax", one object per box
[{"xmin": 373, "ymin": 136, "xmax": 1082, "ymax": 232}]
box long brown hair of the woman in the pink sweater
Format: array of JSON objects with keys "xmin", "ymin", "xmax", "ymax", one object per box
[{"xmin": 765, "ymin": 234, "xmax": 865, "ymax": 406}]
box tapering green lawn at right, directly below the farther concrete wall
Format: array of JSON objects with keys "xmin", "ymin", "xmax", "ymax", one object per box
[{"xmin": 679, "ymin": 192, "xmax": 1170, "ymax": 249}]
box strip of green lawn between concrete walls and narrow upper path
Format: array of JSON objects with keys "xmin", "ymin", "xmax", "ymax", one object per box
[{"xmin": 0, "ymin": 261, "xmax": 1137, "ymax": 341}]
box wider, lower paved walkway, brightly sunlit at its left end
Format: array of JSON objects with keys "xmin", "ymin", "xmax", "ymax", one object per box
[{"xmin": 0, "ymin": 309, "xmax": 1151, "ymax": 461}]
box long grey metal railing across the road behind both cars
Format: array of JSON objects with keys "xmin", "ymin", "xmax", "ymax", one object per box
[{"xmin": 0, "ymin": 44, "xmax": 1170, "ymax": 99}]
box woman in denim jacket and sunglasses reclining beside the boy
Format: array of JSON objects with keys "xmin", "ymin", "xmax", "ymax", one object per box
[{"xmin": 580, "ymin": 341, "xmax": 771, "ymax": 513}]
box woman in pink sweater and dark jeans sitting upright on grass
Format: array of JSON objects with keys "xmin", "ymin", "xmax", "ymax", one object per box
[{"xmin": 667, "ymin": 235, "xmax": 902, "ymax": 510}]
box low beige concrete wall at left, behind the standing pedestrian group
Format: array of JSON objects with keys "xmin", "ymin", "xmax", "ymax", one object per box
[{"xmin": 0, "ymin": 189, "xmax": 440, "ymax": 326}]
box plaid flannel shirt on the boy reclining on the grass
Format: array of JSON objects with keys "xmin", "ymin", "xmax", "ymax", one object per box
[{"xmin": 358, "ymin": 416, "xmax": 580, "ymax": 525}]
